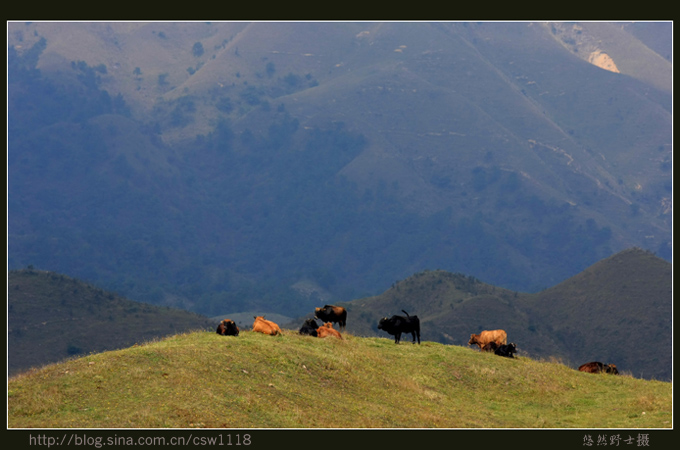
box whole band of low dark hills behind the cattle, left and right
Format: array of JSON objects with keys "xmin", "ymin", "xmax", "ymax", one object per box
[{"xmin": 7, "ymin": 249, "xmax": 672, "ymax": 381}]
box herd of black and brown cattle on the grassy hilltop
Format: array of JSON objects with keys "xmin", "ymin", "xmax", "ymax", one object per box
[{"xmin": 216, "ymin": 305, "xmax": 619, "ymax": 375}]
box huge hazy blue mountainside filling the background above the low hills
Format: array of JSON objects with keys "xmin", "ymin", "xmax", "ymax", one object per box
[{"xmin": 8, "ymin": 22, "xmax": 672, "ymax": 317}]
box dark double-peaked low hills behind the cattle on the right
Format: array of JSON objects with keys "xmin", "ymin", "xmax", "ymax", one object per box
[{"xmin": 334, "ymin": 249, "xmax": 672, "ymax": 380}]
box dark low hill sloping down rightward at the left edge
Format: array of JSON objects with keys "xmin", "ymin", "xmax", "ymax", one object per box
[{"xmin": 7, "ymin": 269, "xmax": 212, "ymax": 375}]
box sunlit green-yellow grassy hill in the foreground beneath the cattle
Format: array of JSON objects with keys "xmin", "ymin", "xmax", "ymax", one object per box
[{"xmin": 8, "ymin": 330, "xmax": 672, "ymax": 428}]
